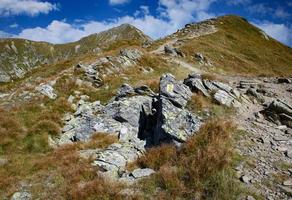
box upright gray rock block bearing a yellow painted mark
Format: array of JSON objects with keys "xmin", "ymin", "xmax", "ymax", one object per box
[{"xmin": 160, "ymin": 74, "xmax": 192, "ymax": 108}]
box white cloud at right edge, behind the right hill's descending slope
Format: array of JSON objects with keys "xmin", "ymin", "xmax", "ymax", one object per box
[{"xmin": 254, "ymin": 21, "xmax": 292, "ymax": 46}]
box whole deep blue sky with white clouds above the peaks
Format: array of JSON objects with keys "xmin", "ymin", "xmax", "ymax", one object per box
[{"xmin": 0, "ymin": 0, "xmax": 292, "ymax": 46}]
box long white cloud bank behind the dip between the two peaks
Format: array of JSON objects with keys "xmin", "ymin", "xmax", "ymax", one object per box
[{"xmin": 5, "ymin": 0, "xmax": 216, "ymax": 43}]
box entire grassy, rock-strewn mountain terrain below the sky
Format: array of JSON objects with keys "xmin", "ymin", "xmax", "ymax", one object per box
[{"xmin": 0, "ymin": 16, "xmax": 292, "ymax": 200}]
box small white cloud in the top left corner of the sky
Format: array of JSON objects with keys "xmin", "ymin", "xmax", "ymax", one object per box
[{"xmin": 0, "ymin": 0, "xmax": 57, "ymax": 16}]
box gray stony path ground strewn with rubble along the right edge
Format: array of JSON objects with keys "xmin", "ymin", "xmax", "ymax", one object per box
[{"xmin": 230, "ymin": 78, "xmax": 292, "ymax": 200}]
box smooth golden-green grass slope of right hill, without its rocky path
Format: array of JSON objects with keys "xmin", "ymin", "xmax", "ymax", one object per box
[{"xmin": 171, "ymin": 16, "xmax": 292, "ymax": 75}]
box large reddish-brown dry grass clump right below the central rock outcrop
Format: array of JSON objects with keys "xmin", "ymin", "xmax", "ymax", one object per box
[{"xmin": 138, "ymin": 119, "xmax": 252, "ymax": 199}]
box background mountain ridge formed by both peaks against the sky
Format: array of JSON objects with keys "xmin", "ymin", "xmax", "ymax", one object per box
[{"xmin": 0, "ymin": 15, "xmax": 292, "ymax": 82}]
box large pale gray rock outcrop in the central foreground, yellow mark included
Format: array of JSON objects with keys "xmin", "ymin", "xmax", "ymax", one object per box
[{"xmin": 56, "ymin": 74, "xmax": 201, "ymax": 181}]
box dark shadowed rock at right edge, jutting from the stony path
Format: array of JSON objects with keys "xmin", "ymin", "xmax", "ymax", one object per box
[{"xmin": 263, "ymin": 99, "xmax": 292, "ymax": 128}]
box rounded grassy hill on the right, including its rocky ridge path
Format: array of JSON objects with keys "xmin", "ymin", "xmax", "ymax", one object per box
[{"xmin": 150, "ymin": 16, "xmax": 292, "ymax": 75}]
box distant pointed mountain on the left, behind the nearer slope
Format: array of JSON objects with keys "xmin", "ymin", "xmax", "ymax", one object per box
[{"xmin": 0, "ymin": 24, "xmax": 152, "ymax": 82}]
